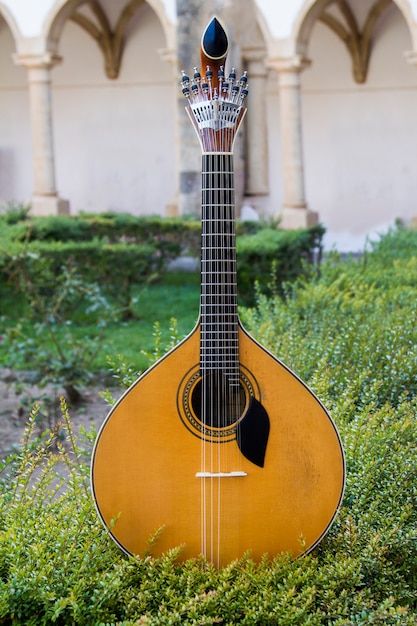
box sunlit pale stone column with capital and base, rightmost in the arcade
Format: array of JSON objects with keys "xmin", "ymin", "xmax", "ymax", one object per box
[{"xmin": 269, "ymin": 56, "xmax": 318, "ymax": 228}]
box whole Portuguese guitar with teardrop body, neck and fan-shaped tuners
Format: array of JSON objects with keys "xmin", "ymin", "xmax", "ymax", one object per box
[{"xmin": 92, "ymin": 18, "xmax": 345, "ymax": 566}]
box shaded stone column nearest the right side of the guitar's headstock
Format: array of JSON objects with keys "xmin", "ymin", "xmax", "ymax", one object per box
[{"xmin": 242, "ymin": 47, "xmax": 269, "ymax": 196}]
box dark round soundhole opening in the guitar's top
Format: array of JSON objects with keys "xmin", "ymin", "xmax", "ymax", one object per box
[{"xmin": 191, "ymin": 372, "xmax": 246, "ymax": 428}]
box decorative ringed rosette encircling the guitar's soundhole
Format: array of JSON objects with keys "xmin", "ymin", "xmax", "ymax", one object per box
[{"xmin": 177, "ymin": 365, "xmax": 260, "ymax": 443}]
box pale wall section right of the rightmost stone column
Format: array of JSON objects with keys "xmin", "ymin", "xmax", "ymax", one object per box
[{"xmin": 302, "ymin": 7, "xmax": 417, "ymax": 249}]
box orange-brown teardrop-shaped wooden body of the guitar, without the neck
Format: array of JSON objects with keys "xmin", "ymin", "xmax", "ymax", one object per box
[{"xmin": 92, "ymin": 324, "xmax": 344, "ymax": 566}]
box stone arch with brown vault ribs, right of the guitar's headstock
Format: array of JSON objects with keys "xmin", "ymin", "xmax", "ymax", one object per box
[{"xmin": 291, "ymin": 0, "xmax": 417, "ymax": 60}]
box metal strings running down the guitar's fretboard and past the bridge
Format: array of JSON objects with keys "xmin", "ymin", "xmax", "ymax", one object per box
[{"xmin": 197, "ymin": 78, "xmax": 244, "ymax": 562}]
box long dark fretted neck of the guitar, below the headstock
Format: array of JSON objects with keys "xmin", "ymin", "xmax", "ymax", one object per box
[{"xmin": 200, "ymin": 153, "xmax": 239, "ymax": 382}]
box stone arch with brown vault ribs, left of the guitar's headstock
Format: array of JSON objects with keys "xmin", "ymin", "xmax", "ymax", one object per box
[{"xmin": 43, "ymin": 0, "xmax": 175, "ymax": 56}]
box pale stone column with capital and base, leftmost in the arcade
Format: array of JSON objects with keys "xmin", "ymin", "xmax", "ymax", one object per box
[{"xmin": 15, "ymin": 53, "xmax": 69, "ymax": 215}]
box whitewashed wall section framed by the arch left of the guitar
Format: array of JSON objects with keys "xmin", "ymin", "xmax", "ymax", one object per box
[{"xmin": 53, "ymin": 0, "xmax": 175, "ymax": 214}]
